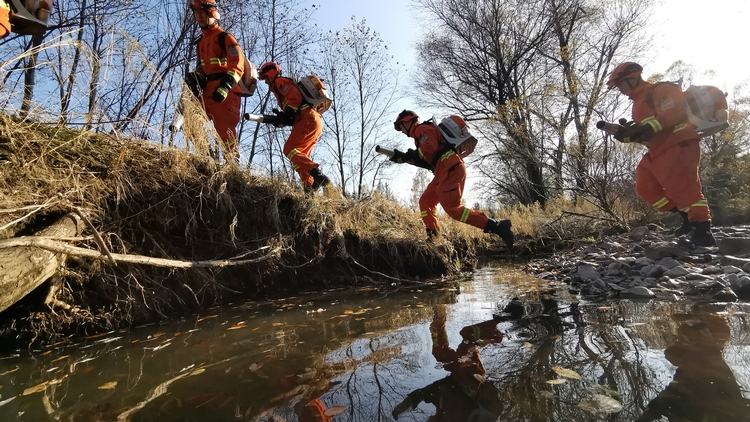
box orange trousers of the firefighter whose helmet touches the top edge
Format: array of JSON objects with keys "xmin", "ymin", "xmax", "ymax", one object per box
[{"xmin": 203, "ymin": 80, "xmax": 240, "ymax": 160}]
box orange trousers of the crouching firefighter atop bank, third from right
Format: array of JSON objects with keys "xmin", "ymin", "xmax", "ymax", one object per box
[{"xmin": 284, "ymin": 105, "xmax": 323, "ymax": 186}]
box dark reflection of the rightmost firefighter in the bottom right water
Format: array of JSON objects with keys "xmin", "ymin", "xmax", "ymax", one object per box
[{"xmin": 638, "ymin": 304, "xmax": 750, "ymax": 422}]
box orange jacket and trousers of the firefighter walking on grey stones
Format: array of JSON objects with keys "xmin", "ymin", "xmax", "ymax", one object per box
[{"xmin": 630, "ymin": 81, "xmax": 711, "ymax": 222}]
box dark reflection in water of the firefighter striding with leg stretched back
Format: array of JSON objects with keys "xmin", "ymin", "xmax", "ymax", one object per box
[{"xmin": 393, "ymin": 307, "xmax": 503, "ymax": 422}]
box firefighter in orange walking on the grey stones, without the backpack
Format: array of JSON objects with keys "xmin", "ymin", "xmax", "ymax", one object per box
[{"xmin": 607, "ymin": 62, "xmax": 716, "ymax": 246}]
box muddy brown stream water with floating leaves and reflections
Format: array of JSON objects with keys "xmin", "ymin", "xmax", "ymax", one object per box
[{"xmin": 0, "ymin": 268, "xmax": 750, "ymax": 422}]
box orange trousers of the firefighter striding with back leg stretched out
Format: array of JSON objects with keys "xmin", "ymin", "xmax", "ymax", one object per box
[{"xmin": 419, "ymin": 153, "xmax": 494, "ymax": 230}]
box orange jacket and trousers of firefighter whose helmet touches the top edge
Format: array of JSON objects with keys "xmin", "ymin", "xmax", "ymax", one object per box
[{"xmin": 198, "ymin": 25, "xmax": 245, "ymax": 157}]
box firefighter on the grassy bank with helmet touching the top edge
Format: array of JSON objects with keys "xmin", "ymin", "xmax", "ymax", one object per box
[{"xmin": 185, "ymin": 0, "xmax": 245, "ymax": 162}]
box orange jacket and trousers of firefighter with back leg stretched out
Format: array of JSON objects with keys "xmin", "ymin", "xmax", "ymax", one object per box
[{"xmin": 409, "ymin": 123, "xmax": 487, "ymax": 230}]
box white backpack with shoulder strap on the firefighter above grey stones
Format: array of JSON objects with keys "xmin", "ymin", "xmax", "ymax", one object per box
[{"xmin": 646, "ymin": 82, "xmax": 729, "ymax": 138}]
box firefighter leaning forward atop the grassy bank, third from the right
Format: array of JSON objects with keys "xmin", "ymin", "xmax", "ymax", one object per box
[{"xmin": 258, "ymin": 62, "xmax": 331, "ymax": 193}]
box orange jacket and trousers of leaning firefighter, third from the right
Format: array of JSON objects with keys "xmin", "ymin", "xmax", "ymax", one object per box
[{"xmin": 270, "ymin": 76, "xmax": 323, "ymax": 186}]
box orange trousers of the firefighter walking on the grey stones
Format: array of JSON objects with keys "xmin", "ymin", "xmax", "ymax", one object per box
[{"xmin": 635, "ymin": 139, "xmax": 711, "ymax": 222}]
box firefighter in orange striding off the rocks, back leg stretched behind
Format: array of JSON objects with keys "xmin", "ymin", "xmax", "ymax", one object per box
[{"xmin": 391, "ymin": 110, "xmax": 514, "ymax": 249}]
